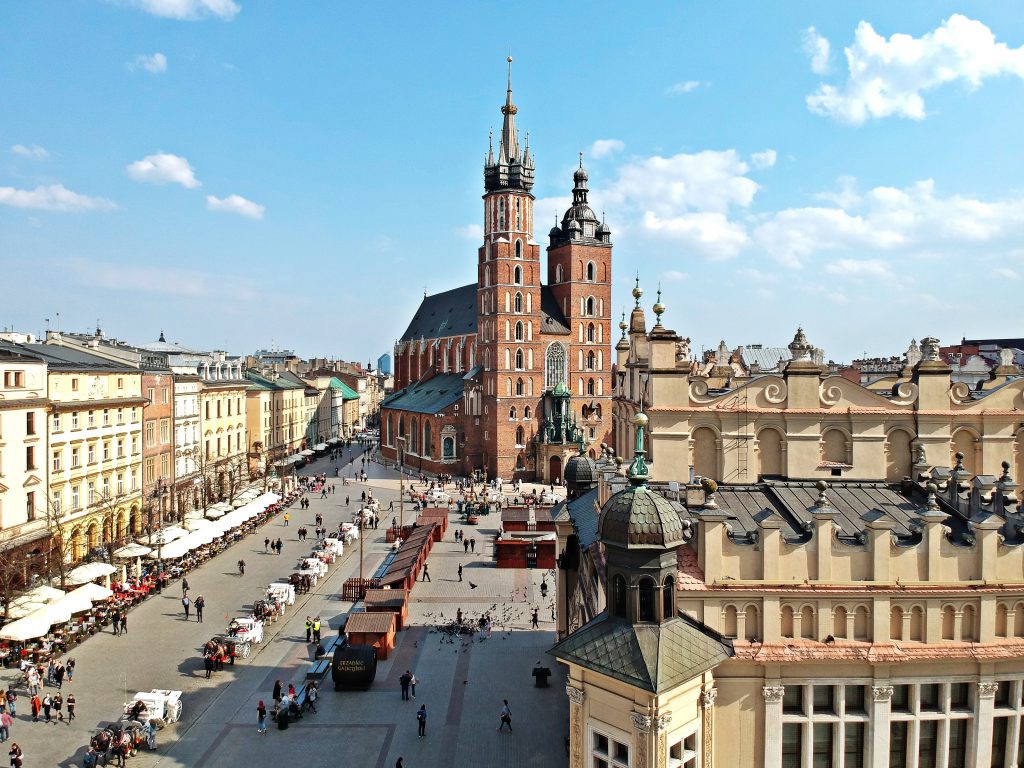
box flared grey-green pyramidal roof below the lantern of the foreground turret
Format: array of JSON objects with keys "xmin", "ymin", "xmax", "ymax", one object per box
[{"xmin": 548, "ymin": 611, "xmax": 733, "ymax": 693}]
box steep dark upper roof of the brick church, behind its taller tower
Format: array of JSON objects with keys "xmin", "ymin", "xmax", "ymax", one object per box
[{"xmin": 398, "ymin": 283, "xmax": 571, "ymax": 341}]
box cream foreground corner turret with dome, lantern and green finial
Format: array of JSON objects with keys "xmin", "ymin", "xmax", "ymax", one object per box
[{"xmin": 550, "ymin": 413, "xmax": 733, "ymax": 768}]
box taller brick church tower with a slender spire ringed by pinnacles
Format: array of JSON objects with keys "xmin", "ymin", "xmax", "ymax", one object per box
[{"xmin": 477, "ymin": 56, "xmax": 544, "ymax": 477}]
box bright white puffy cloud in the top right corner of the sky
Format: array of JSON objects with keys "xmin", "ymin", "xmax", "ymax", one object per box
[{"xmin": 807, "ymin": 13, "xmax": 1024, "ymax": 125}]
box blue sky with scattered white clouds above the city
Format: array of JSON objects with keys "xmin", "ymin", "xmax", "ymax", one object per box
[{"xmin": 0, "ymin": 0, "xmax": 1024, "ymax": 361}]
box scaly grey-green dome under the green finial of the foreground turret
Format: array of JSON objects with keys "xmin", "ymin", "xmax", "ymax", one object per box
[{"xmin": 598, "ymin": 485, "xmax": 683, "ymax": 549}]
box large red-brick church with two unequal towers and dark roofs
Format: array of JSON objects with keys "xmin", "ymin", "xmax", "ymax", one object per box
[{"xmin": 381, "ymin": 57, "xmax": 611, "ymax": 481}]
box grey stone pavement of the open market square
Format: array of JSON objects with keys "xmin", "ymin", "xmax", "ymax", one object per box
[{"xmin": 3, "ymin": 444, "xmax": 567, "ymax": 768}]
